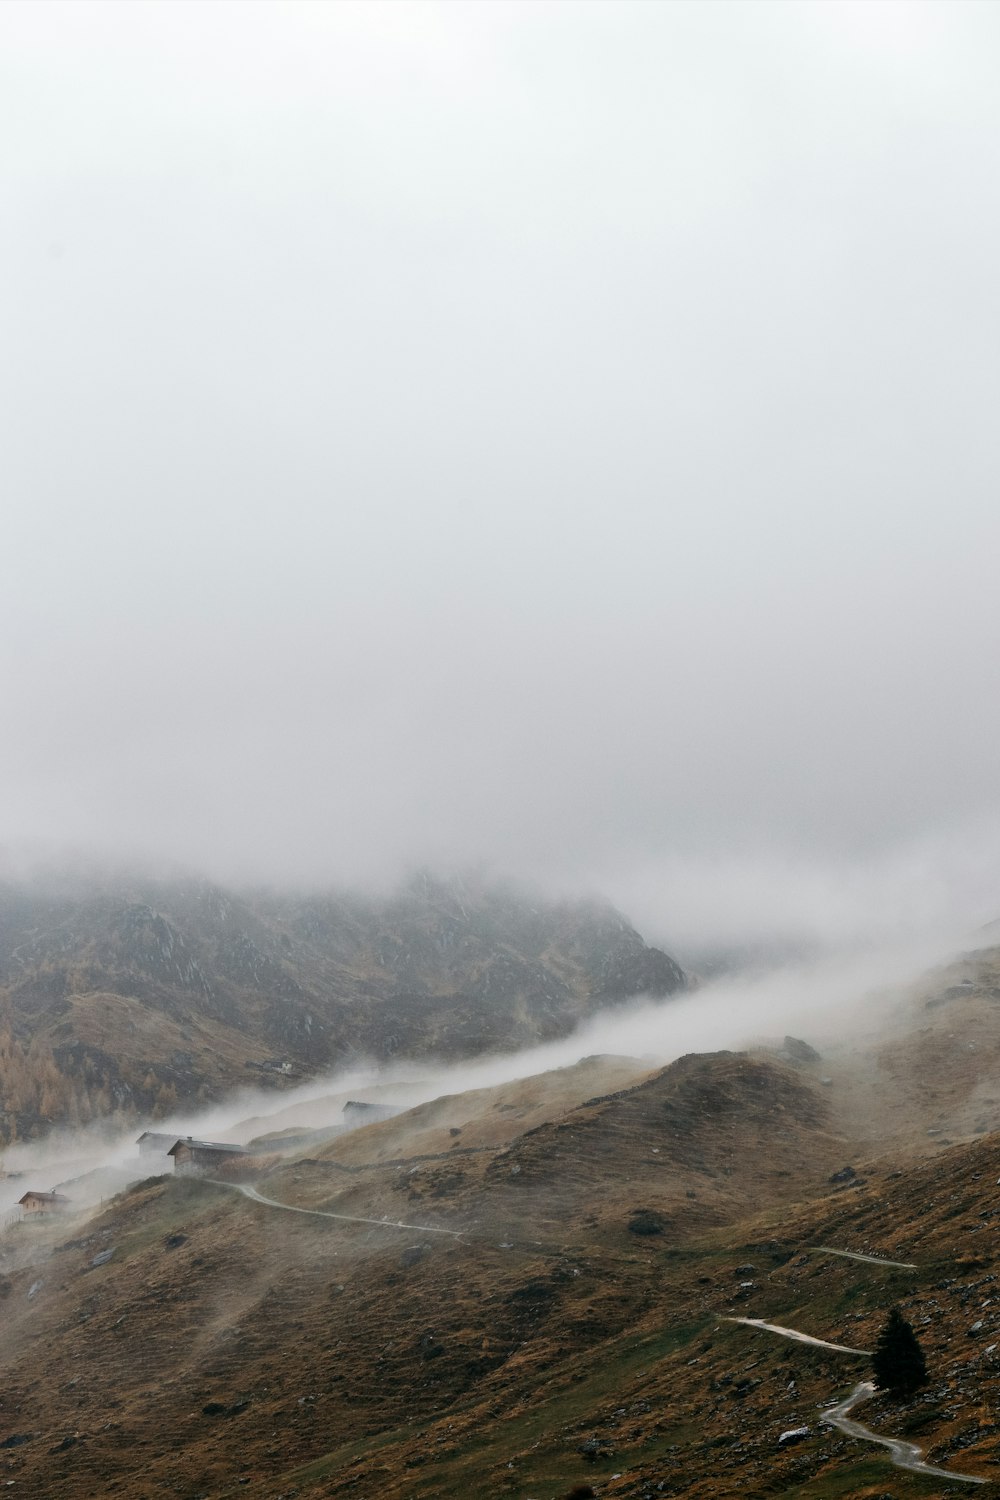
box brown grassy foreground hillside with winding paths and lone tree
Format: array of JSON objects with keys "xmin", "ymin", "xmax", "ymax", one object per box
[{"xmin": 0, "ymin": 953, "xmax": 1000, "ymax": 1500}]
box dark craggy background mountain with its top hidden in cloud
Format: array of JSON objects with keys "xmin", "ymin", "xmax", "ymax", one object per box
[{"xmin": 0, "ymin": 875, "xmax": 685, "ymax": 1136}]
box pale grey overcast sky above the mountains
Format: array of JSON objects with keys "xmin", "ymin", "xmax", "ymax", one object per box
[{"xmin": 0, "ymin": 0, "xmax": 1000, "ymax": 932}]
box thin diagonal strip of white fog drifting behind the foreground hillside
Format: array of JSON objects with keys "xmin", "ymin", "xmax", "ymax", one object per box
[{"xmin": 0, "ymin": 932, "xmax": 967, "ymax": 1215}]
